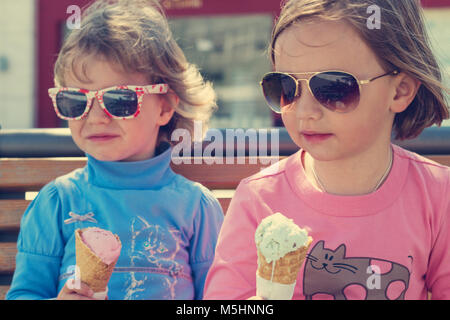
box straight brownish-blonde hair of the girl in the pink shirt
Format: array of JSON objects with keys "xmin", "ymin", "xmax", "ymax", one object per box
[{"xmin": 269, "ymin": 0, "xmax": 449, "ymax": 140}]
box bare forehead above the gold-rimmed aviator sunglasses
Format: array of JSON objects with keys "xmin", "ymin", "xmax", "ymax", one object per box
[{"xmin": 275, "ymin": 19, "xmax": 377, "ymax": 72}]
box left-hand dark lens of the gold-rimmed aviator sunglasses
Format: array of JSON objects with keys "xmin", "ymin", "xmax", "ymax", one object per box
[{"xmin": 261, "ymin": 73, "xmax": 297, "ymax": 112}]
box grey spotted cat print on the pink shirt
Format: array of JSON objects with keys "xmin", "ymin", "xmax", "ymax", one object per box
[{"xmin": 303, "ymin": 241, "xmax": 410, "ymax": 300}]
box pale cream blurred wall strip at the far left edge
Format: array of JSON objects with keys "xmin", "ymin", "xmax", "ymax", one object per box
[{"xmin": 0, "ymin": 0, "xmax": 36, "ymax": 128}]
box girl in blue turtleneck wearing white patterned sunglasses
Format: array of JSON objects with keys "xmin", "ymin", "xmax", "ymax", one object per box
[{"xmin": 7, "ymin": 0, "xmax": 223, "ymax": 299}]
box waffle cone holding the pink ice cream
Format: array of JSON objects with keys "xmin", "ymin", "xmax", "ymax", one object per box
[{"xmin": 75, "ymin": 229, "xmax": 120, "ymax": 292}]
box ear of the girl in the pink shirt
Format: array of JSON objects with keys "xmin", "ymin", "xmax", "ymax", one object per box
[{"xmin": 390, "ymin": 72, "xmax": 422, "ymax": 113}]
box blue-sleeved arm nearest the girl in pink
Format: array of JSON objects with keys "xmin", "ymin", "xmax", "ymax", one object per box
[{"xmin": 190, "ymin": 191, "xmax": 223, "ymax": 300}]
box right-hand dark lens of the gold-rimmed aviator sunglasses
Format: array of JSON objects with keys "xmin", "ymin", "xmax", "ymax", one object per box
[{"xmin": 309, "ymin": 72, "xmax": 359, "ymax": 112}]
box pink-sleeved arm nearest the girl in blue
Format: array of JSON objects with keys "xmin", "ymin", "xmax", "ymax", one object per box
[{"xmin": 205, "ymin": 182, "xmax": 263, "ymax": 300}]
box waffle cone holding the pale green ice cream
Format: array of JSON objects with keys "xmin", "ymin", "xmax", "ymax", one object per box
[{"xmin": 257, "ymin": 237, "xmax": 312, "ymax": 284}]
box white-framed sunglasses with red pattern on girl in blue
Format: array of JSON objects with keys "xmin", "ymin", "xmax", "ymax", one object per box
[{"xmin": 48, "ymin": 83, "xmax": 169, "ymax": 120}]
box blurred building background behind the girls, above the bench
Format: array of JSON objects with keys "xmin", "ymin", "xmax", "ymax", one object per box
[{"xmin": 0, "ymin": 0, "xmax": 450, "ymax": 129}]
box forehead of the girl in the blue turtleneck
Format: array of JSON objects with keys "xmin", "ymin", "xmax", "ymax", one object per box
[{"xmin": 65, "ymin": 56, "xmax": 148, "ymax": 90}]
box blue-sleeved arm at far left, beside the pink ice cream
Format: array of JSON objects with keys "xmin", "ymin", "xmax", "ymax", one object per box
[{"xmin": 6, "ymin": 183, "xmax": 64, "ymax": 300}]
